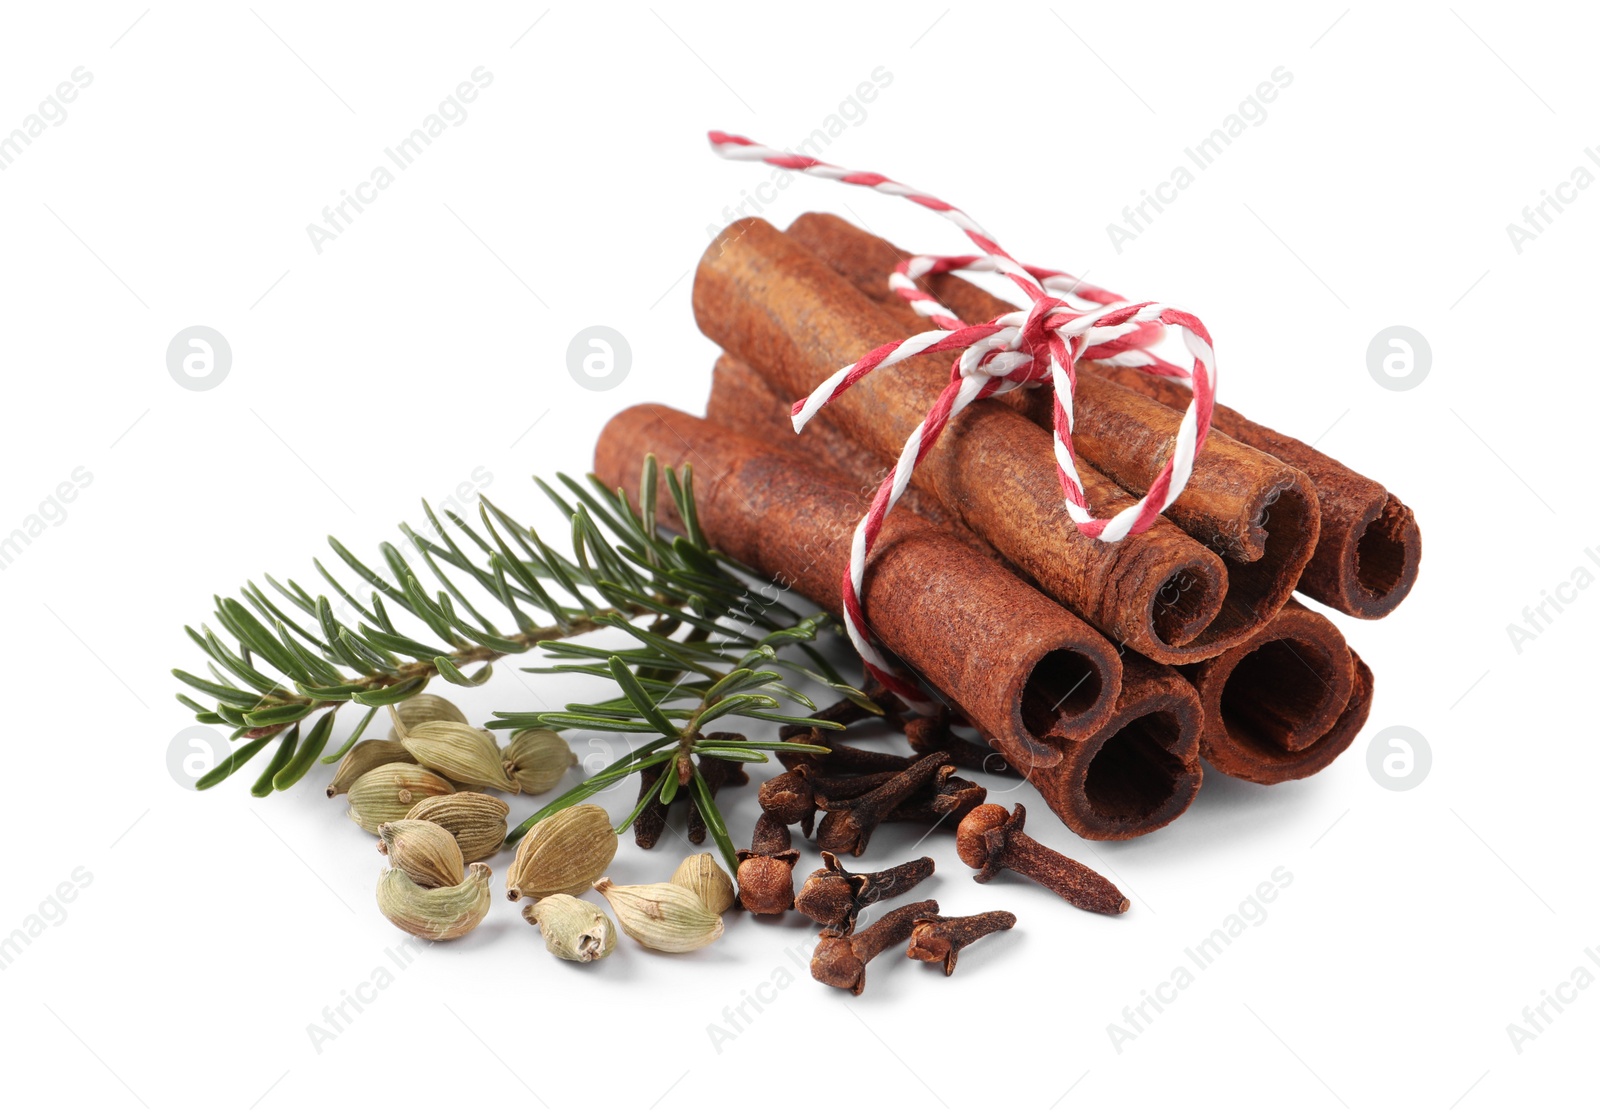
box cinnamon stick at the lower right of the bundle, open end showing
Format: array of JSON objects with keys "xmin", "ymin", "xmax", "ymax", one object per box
[{"xmin": 1177, "ymin": 602, "xmax": 1373, "ymax": 784}]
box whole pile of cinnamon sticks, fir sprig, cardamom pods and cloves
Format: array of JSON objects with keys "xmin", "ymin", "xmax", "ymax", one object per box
[{"xmin": 178, "ymin": 161, "xmax": 1421, "ymax": 994}]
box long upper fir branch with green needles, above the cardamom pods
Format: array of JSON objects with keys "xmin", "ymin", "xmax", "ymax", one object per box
[{"xmin": 173, "ymin": 458, "xmax": 814, "ymax": 796}]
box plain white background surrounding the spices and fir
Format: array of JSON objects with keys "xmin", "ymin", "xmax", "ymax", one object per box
[{"xmin": 0, "ymin": 0, "xmax": 1600, "ymax": 1114}]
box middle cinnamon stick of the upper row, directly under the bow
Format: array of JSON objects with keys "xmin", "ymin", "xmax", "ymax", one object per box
[{"xmin": 789, "ymin": 213, "xmax": 1318, "ymax": 626}]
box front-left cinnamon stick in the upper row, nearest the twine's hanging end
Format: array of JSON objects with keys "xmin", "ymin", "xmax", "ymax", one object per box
[{"xmin": 694, "ymin": 218, "xmax": 1235, "ymax": 663}]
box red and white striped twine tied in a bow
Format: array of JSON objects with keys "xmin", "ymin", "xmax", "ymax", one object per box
[{"xmin": 710, "ymin": 131, "xmax": 1216, "ymax": 711}]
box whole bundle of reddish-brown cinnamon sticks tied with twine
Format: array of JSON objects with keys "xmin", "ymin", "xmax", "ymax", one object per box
[{"xmin": 595, "ymin": 215, "xmax": 1421, "ymax": 839}]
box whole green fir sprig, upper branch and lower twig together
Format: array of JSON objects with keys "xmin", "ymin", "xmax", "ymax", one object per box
[{"xmin": 174, "ymin": 458, "xmax": 872, "ymax": 826}]
